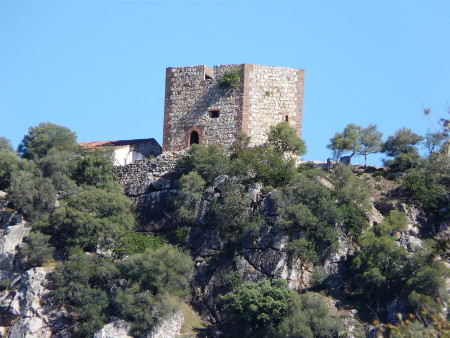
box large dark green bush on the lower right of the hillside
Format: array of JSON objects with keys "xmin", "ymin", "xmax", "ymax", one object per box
[{"xmin": 351, "ymin": 211, "xmax": 449, "ymax": 320}]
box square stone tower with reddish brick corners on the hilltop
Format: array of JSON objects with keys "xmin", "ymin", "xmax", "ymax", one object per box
[{"xmin": 163, "ymin": 64, "xmax": 304, "ymax": 151}]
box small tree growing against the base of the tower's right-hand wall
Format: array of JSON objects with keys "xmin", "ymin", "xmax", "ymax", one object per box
[{"xmin": 268, "ymin": 121, "xmax": 306, "ymax": 156}]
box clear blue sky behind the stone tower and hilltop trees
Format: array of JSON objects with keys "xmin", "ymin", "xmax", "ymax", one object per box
[{"xmin": 0, "ymin": 0, "xmax": 450, "ymax": 164}]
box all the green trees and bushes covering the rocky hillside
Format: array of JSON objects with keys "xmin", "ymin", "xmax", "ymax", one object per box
[{"xmin": 0, "ymin": 115, "xmax": 450, "ymax": 337}]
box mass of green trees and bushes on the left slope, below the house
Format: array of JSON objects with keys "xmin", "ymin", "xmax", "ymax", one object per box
[{"xmin": 0, "ymin": 123, "xmax": 193, "ymax": 337}]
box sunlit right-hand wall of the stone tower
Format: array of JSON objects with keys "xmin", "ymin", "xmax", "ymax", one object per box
[{"xmin": 243, "ymin": 65, "xmax": 304, "ymax": 145}]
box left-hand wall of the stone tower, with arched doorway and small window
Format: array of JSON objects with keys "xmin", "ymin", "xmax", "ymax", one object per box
[{"xmin": 163, "ymin": 65, "xmax": 242, "ymax": 151}]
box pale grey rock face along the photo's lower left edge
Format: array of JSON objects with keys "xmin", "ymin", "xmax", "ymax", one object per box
[{"xmin": 0, "ymin": 192, "xmax": 62, "ymax": 337}]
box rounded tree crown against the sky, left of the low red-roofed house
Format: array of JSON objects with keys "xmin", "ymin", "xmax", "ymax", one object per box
[{"xmin": 18, "ymin": 122, "xmax": 78, "ymax": 160}]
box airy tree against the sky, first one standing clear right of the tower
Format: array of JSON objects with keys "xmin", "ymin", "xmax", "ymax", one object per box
[{"xmin": 327, "ymin": 123, "xmax": 382, "ymax": 166}]
